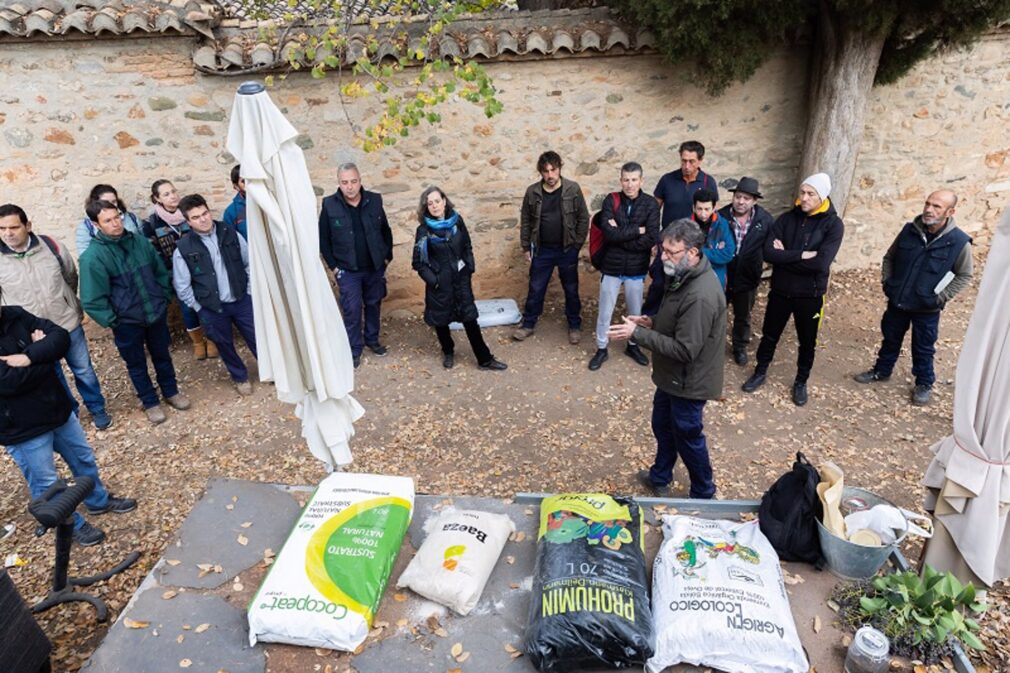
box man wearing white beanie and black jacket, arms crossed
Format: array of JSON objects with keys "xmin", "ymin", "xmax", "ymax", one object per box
[{"xmin": 742, "ymin": 173, "xmax": 844, "ymax": 406}]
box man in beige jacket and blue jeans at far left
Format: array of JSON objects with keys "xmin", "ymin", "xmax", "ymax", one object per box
[{"xmin": 0, "ymin": 203, "xmax": 112, "ymax": 429}]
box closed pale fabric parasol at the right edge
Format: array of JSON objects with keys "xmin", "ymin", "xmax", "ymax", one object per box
[{"xmin": 922, "ymin": 203, "xmax": 1010, "ymax": 586}]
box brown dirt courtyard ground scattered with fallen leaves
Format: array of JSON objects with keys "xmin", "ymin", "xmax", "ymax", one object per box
[{"xmin": 0, "ymin": 265, "xmax": 1010, "ymax": 671}]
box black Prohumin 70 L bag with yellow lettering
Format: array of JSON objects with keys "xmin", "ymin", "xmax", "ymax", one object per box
[{"xmin": 524, "ymin": 493, "xmax": 652, "ymax": 673}]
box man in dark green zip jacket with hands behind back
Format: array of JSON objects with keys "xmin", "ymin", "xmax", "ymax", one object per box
[{"xmin": 80, "ymin": 201, "xmax": 190, "ymax": 423}]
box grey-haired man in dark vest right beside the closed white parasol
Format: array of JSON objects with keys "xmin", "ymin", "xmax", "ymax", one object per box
[{"xmin": 319, "ymin": 164, "xmax": 393, "ymax": 367}]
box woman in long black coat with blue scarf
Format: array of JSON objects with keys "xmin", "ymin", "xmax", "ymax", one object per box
[{"xmin": 411, "ymin": 187, "xmax": 507, "ymax": 370}]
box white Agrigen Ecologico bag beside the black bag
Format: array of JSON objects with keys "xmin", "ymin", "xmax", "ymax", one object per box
[{"xmin": 646, "ymin": 515, "xmax": 810, "ymax": 673}]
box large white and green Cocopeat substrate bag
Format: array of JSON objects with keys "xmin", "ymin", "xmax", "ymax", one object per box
[{"xmin": 248, "ymin": 472, "xmax": 414, "ymax": 652}]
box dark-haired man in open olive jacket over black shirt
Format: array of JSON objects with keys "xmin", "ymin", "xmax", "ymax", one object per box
[{"xmin": 512, "ymin": 151, "xmax": 589, "ymax": 345}]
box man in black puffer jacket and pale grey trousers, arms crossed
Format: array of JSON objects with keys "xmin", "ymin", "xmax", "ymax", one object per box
[{"xmin": 589, "ymin": 162, "xmax": 660, "ymax": 372}]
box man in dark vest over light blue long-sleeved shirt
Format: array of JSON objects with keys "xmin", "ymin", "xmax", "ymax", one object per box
[{"xmin": 172, "ymin": 194, "xmax": 256, "ymax": 395}]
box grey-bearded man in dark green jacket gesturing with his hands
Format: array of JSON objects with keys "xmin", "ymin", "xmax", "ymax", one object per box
[{"xmin": 608, "ymin": 219, "xmax": 726, "ymax": 498}]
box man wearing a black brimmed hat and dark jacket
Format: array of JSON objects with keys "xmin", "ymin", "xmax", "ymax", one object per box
[{"xmin": 719, "ymin": 177, "xmax": 774, "ymax": 366}]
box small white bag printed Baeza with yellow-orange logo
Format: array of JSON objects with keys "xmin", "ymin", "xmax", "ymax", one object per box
[{"xmin": 396, "ymin": 508, "xmax": 515, "ymax": 614}]
